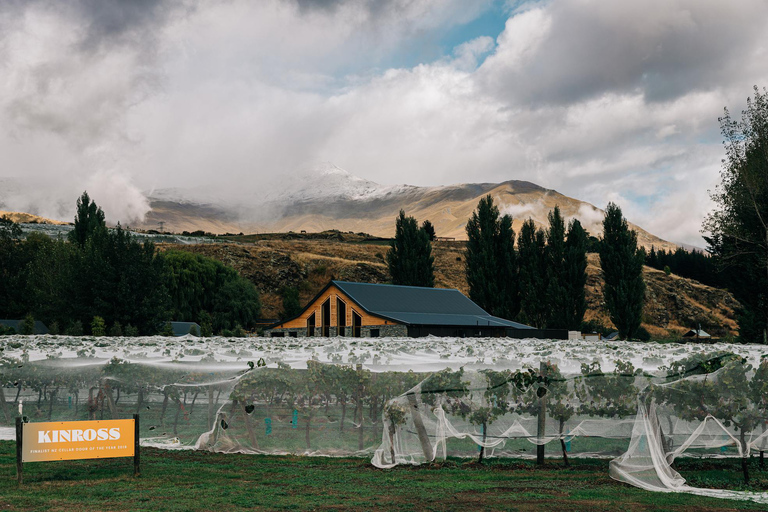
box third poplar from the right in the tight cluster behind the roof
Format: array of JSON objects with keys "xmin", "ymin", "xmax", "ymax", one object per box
[{"xmin": 517, "ymin": 218, "xmax": 550, "ymax": 329}]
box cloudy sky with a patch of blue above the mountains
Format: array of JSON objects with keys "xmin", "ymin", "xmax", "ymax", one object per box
[{"xmin": 0, "ymin": 0, "xmax": 768, "ymax": 246}]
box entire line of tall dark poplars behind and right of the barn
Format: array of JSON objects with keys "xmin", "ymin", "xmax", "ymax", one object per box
[{"xmin": 386, "ymin": 195, "xmax": 647, "ymax": 339}]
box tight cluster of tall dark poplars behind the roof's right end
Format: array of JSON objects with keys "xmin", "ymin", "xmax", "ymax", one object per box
[{"xmin": 465, "ymin": 195, "xmax": 587, "ymax": 329}]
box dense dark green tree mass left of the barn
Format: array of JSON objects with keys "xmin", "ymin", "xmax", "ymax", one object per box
[{"xmin": 0, "ymin": 192, "xmax": 261, "ymax": 335}]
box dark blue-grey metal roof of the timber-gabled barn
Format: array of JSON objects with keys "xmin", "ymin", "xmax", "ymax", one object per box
[{"xmin": 331, "ymin": 281, "xmax": 533, "ymax": 329}]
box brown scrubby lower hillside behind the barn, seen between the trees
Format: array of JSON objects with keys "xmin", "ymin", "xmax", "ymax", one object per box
[{"xmin": 164, "ymin": 240, "xmax": 738, "ymax": 338}]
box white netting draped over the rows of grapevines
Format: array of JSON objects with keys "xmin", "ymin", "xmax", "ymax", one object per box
[{"xmin": 0, "ymin": 336, "xmax": 768, "ymax": 502}]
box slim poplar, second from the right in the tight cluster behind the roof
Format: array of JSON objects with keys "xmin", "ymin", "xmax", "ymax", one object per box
[{"xmin": 544, "ymin": 206, "xmax": 568, "ymax": 329}]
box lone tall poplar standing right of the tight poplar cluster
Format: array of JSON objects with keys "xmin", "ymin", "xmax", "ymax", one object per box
[{"xmin": 600, "ymin": 203, "xmax": 645, "ymax": 339}]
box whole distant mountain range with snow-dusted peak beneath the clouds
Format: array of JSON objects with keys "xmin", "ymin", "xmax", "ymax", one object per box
[{"xmin": 139, "ymin": 165, "xmax": 676, "ymax": 250}]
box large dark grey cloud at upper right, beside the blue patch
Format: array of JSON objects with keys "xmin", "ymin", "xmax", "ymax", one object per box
[{"xmin": 483, "ymin": 0, "xmax": 768, "ymax": 104}]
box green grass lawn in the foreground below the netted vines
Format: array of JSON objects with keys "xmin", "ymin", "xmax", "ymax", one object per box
[{"xmin": 0, "ymin": 441, "xmax": 768, "ymax": 512}]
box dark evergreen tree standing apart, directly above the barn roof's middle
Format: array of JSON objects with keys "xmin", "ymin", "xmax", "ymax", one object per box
[{"xmin": 387, "ymin": 210, "xmax": 435, "ymax": 288}]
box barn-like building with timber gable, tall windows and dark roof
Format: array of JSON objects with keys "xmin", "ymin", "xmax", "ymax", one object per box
[{"xmin": 267, "ymin": 281, "xmax": 567, "ymax": 338}]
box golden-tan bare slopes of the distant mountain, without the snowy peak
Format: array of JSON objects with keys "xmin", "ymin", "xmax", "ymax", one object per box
[{"xmin": 138, "ymin": 181, "xmax": 677, "ymax": 250}]
